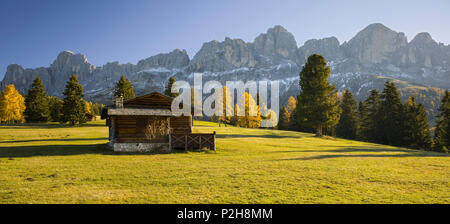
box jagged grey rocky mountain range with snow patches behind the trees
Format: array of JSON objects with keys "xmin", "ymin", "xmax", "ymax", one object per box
[{"xmin": 0, "ymin": 23, "xmax": 450, "ymax": 120}]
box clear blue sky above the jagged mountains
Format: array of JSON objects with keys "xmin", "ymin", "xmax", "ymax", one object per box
[{"xmin": 0, "ymin": 0, "xmax": 450, "ymax": 79}]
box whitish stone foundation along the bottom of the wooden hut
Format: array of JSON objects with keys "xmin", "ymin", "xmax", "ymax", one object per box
[{"xmin": 110, "ymin": 143, "xmax": 172, "ymax": 153}]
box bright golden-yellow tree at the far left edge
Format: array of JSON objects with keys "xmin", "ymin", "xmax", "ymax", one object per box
[{"xmin": 0, "ymin": 84, "xmax": 25, "ymax": 123}]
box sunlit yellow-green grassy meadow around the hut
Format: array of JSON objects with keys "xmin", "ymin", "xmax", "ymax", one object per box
[{"xmin": 0, "ymin": 122, "xmax": 450, "ymax": 203}]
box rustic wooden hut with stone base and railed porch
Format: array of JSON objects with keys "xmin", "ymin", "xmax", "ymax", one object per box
[{"xmin": 102, "ymin": 92, "xmax": 215, "ymax": 152}]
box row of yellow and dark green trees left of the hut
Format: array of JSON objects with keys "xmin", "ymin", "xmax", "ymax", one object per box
[{"xmin": 0, "ymin": 75, "xmax": 103, "ymax": 125}]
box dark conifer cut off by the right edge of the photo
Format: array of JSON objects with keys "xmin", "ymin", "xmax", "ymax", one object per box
[{"xmin": 433, "ymin": 90, "xmax": 450, "ymax": 153}]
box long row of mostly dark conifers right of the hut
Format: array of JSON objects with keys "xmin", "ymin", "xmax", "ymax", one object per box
[{"xmin": 278, "ymin": 54, "xmax": 450, "ymax": 152}]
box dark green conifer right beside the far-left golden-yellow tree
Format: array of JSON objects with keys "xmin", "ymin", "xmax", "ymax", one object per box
[{"xmin": 24, "ymin": 76, "xmax": 50, "ymax": 122}]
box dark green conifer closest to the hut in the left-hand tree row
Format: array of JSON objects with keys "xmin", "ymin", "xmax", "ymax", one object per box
[{"xmin": 61, "ymin": 75, "xmax": 86, "ymax": 125}]
